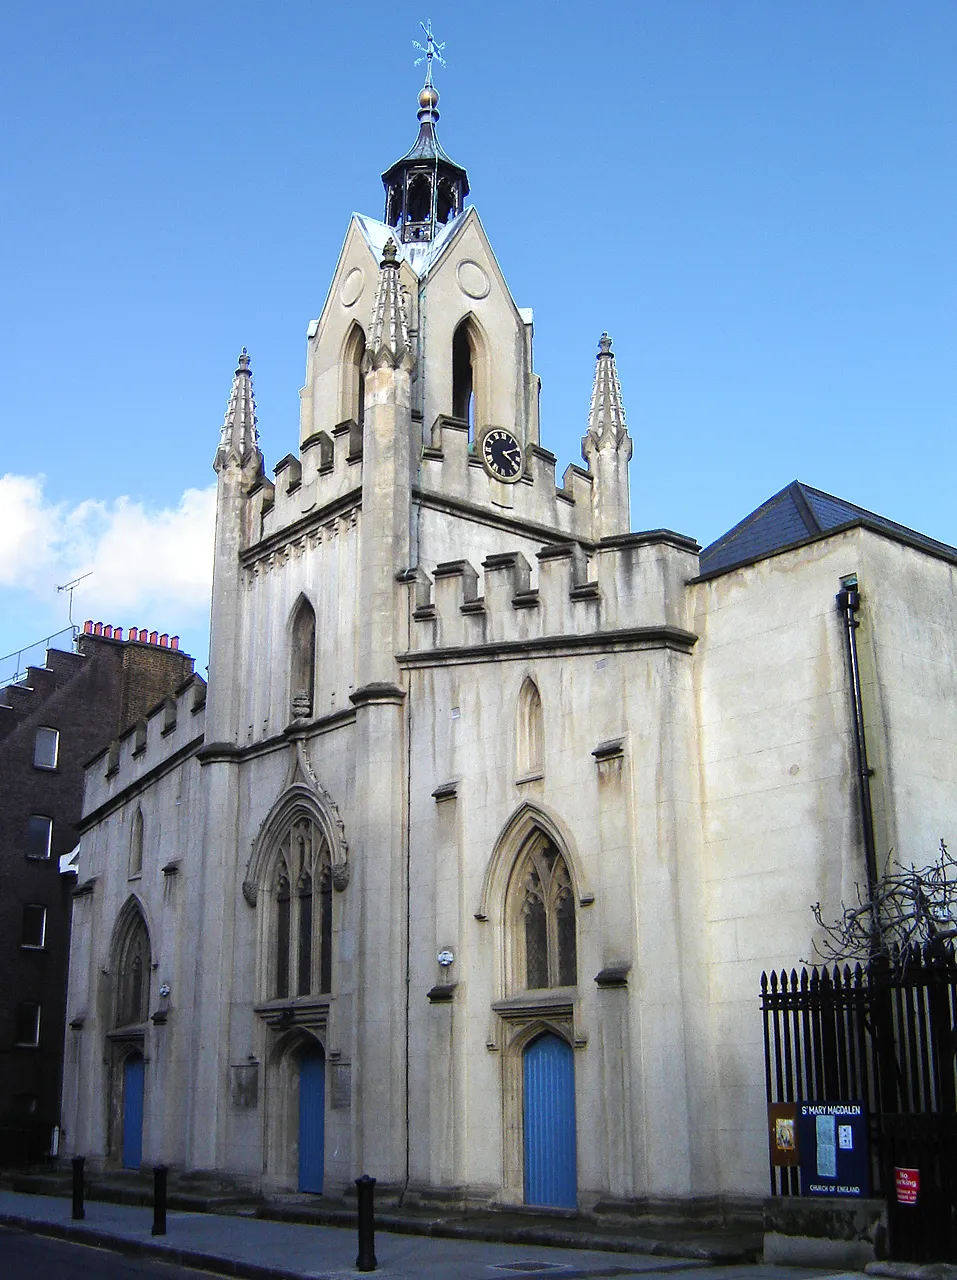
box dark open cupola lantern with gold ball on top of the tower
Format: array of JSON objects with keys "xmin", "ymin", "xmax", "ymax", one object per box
[{"xmin": 383, "ymin": 81, "xmax": 468, "ymax": 244}]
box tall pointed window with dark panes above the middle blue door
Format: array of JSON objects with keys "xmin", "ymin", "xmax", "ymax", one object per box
[{"xmin": 267, "ymin": 817, "xmax": 333, "ymax": 1000}]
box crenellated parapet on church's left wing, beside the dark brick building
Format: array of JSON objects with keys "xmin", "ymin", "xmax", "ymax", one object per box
[{"xmin": 83, "ymin": 675, "xmax": 206, "ymax": 814}]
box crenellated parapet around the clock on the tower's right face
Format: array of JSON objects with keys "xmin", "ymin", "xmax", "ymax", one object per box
[{"xmin": 421, "ymin": 413, "xmax": 595, "ymax": 541}]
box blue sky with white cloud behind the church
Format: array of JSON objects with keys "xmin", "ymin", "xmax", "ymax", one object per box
[{"xmin": 0, "ymin": 0, "xmax": 957, "ymax": 678}]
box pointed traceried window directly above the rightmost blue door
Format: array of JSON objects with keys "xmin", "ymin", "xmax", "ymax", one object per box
[{"xmin": 509, "ymin": 837, "xmax": 578, "ymax": 989}]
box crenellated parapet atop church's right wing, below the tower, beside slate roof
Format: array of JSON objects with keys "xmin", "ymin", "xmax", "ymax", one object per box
[{"xmin": 403, "ymin": 530, "xmax": 699, "ymax": 653}]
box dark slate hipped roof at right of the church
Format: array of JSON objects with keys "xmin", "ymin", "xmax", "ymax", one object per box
[{"xmin": 699, "ymin": 480, "xmax": 957, "ymax": 577}]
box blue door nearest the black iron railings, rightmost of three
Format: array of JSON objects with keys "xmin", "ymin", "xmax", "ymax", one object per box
[{"xmin": 522, "ymin": 1034, "xmax": 578, "ymax": 1208}]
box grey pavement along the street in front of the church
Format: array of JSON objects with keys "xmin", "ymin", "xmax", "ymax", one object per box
[{"xmin": 0, "ymin": 1190, "xmax": 875, "ymax": 1280}]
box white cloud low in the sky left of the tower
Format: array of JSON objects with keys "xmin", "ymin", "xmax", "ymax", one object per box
[{"xmin": 0, "ymin": 475, "xmax": 216, "ymax": 632}]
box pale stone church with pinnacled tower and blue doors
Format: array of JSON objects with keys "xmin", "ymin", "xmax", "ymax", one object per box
[{"xmin": 63, "ymin": 81, "xmax": 957, "ymax": 1210}]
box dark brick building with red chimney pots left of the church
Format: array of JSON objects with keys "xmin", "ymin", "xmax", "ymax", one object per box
[{"xmin": 0, "ymin": 622, "xmax": 193, "ymax": 1164}]
